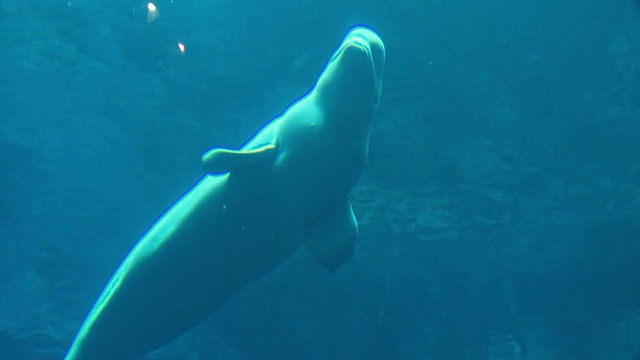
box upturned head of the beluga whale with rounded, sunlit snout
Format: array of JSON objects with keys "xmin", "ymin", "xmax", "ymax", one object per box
[{"xmin": 312, "ymin": 26, "xmax": 385, "ymax": 129}]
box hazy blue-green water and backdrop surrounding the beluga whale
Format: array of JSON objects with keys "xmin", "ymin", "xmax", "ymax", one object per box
[{"xmin": 0, "ymin": 0, "xmax": 640, "ymax": 360}]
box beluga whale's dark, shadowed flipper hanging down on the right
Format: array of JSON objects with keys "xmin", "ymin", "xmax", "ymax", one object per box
[{"xmin": 304, "ymin": 200, "xmax": 358, "ymax": 271}]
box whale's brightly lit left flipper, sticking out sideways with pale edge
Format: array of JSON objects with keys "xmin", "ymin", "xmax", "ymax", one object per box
[{"xmin": 202, "ymin": 144, "xmax": 277, "ymax": 175}]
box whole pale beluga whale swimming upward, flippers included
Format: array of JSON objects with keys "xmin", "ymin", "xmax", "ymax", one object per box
[{"xmin": 65, "ymin": 26, "xmax": 385, "ymax": 360}]
